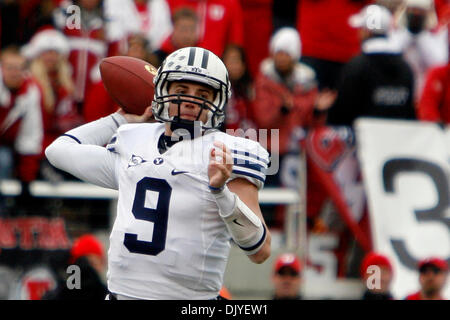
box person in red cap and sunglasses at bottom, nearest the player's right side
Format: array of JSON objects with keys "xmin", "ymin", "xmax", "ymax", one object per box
[{"xmin": 272, "ymin": 253, "xmax": 302, "ymax": 300}]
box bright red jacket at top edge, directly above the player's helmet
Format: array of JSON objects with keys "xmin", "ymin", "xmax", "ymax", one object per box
[{"xmin": 168, "ymin": 0, "xmax": 244, "ymax": 57}]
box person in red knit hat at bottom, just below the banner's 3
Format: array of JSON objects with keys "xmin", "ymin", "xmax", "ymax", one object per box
[{"xmin": 361, "ymin": 252, "xmax": 393, "ymax": 300}]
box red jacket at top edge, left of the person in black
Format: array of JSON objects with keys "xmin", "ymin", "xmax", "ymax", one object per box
[{"xmin": 297, "ymin": 0, "xmax": 372, "ymax": 63}]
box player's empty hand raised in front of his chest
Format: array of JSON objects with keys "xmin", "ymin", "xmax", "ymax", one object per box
[{"xmin": 208, "ymin": 141, "xmax": 233, "ymax": 188}]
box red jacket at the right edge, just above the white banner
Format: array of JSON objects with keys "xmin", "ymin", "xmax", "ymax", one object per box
[{"xmin": 417, "ymin": 65, "xmax": 450, "ymax": 124}]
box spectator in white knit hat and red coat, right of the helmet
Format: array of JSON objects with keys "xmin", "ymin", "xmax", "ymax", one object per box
[{"xmin": 253, "ymin": 27, "xmax": 335, "ymax": 228}]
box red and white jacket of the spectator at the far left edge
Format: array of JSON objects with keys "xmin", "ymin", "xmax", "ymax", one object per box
[{"xmin": 0, "ymin": 75, "xmax": 44, "ymax": 182}]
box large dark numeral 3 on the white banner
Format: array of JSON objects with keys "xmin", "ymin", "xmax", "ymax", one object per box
[{"xmin": 383, "ymin": 158, "xmax": 450, "ymax": 269}]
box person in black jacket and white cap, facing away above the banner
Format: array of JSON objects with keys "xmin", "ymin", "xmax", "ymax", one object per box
[{"xmin": 328, "ymin": 5, "xmax": 416, "ymax": 126}]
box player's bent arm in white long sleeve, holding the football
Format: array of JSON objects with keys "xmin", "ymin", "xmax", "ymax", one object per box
[{"xmin": 45, "ymin": 108, "xmax": 151, "ymax": 189}]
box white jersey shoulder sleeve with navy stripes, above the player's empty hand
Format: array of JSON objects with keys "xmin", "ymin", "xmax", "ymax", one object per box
[{"xmin": 228, "ymin": 138, "xmax": 269, "ymax": 190}]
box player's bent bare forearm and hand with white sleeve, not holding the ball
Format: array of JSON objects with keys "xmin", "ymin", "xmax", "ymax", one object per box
[{"xmin": 208, "ymin": 142, "xmax": 271, "ymax": 263}]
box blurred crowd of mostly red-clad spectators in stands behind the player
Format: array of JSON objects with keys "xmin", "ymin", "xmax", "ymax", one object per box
[{"xmin": 0, "ymin": 0, "xmax": 450, "ymax": 298}]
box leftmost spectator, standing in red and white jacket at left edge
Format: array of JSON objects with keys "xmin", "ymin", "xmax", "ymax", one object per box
[{"xmin": 0, "ymin": 47, "xmax": 44, "ymax": 198}]
